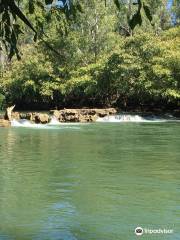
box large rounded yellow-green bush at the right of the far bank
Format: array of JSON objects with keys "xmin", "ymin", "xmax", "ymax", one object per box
[{"xmin": 98, "ymin": 28, "xmax": 180, "ymax": 108}]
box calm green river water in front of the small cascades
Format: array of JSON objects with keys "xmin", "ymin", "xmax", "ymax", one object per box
[{"xmin": 0, "ymin": 122, "xmax": 180, "ymax": 240}]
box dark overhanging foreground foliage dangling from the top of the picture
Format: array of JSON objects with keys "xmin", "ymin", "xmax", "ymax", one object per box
[{"xmin": 0, "ymin": 0, "xmax": 152, "ymax": 59}]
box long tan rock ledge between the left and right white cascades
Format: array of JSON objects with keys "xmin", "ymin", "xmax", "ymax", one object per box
[{"xmin": 50, "ymin": 108, "xmax": 117, "ymax": 122}]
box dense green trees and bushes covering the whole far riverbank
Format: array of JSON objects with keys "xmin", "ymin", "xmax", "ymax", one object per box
[{"xmin": 0, "ymin": 0, "xmax": 180, "ymax": 109}]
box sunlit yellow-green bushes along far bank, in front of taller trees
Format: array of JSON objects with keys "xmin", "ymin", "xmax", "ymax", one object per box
[{"xmin": 0, "ymin": 24, "xmax": 180, "ymax": 106}]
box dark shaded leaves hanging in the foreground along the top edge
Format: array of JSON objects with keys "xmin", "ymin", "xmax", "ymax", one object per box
[{"xmin": 0, "ymin": 0, "xmax": 152, "ymax": 59}]
